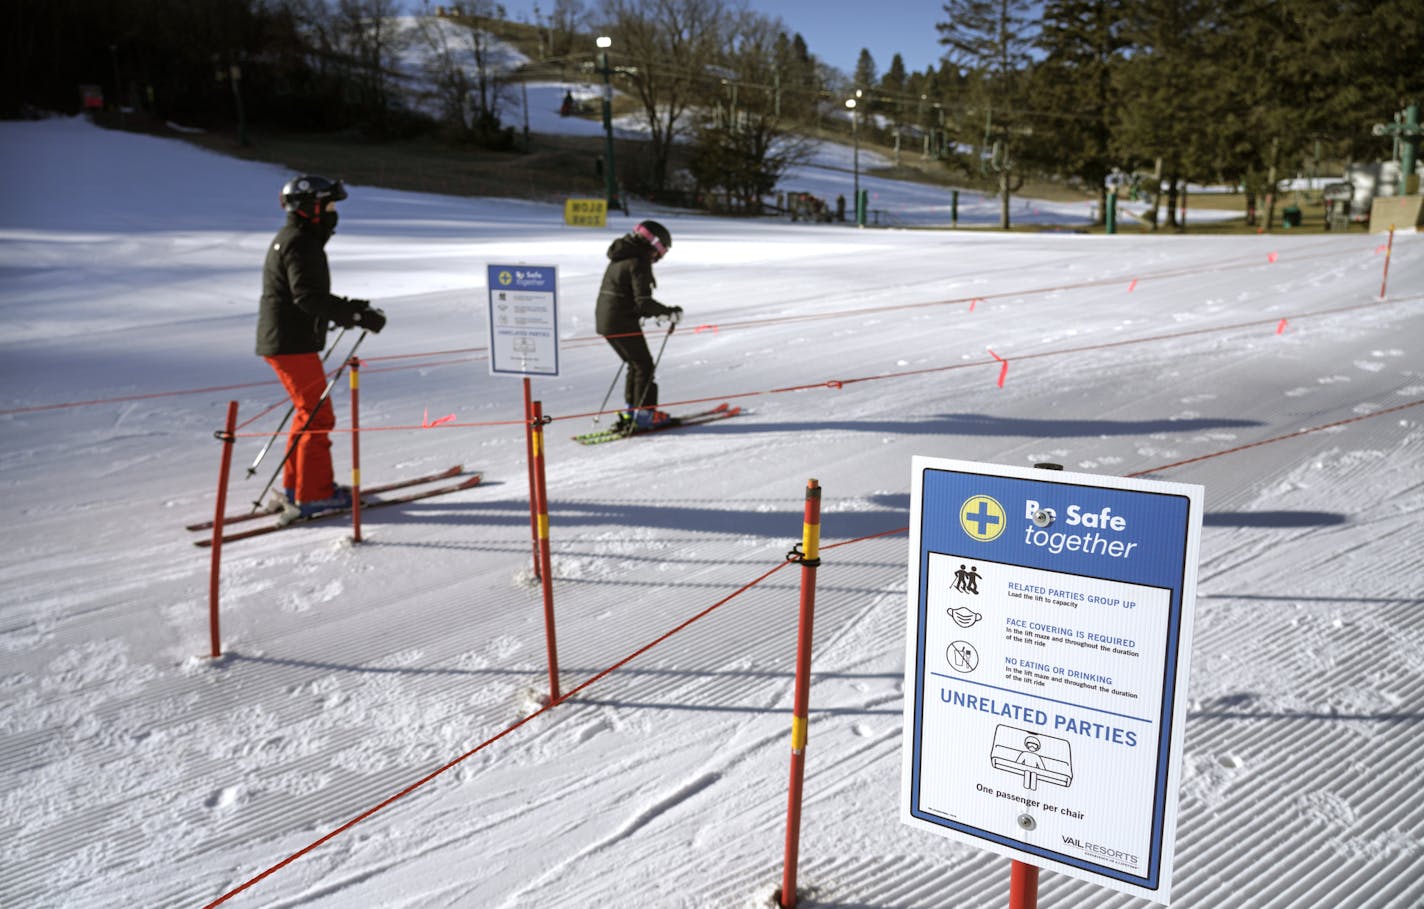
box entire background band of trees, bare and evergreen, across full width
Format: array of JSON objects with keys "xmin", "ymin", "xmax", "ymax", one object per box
[{"xmin": 0, "ymin": 0, "xmax": 1424, "ymax": 227}]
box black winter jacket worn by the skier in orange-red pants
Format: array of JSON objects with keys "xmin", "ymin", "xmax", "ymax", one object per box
[{"xmin": 258, "ymin": 215, "xmax": 357, "ymax": 356}]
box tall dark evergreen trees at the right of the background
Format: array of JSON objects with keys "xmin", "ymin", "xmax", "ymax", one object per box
[{"xmin": 906, "ymin": 0, "xmax": 1424, "ymax": 227}]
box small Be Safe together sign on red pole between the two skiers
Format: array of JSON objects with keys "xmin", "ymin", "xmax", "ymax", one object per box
[{"xmin": 487, "ymin": 265, "xmax": 558, "ymax": 376}]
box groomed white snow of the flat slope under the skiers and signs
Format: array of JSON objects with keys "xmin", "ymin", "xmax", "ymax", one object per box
[{"xmin": 0, "ymin": 113, "xmax": 1424, "ymax": 909}]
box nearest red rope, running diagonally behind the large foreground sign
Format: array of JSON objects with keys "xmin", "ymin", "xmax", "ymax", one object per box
[{"xmin": 204, "ymin": 399, "xmax": 1424, "ymax": 909}]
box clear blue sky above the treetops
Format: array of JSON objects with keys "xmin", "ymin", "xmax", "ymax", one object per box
[{"xmin": 500, "ymin": 0, "xmax": 944, "ymax": 76}]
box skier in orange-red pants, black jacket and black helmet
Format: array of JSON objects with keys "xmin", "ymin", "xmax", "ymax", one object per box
[{"xmin": 256, "ymin": 174, "xmax": 386, "ymax": 517}]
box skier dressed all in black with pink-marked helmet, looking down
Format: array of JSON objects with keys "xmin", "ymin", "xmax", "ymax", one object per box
[{"xmin": 594, "ymin": 221, "xmax": 682, "ymax": 429}]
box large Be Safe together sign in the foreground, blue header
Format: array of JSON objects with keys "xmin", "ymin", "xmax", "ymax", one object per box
[{"xmin": 901, "ymin": 457, "xmax": 1202, "ymax": 903}]
